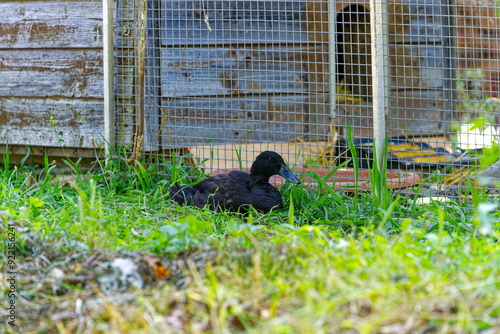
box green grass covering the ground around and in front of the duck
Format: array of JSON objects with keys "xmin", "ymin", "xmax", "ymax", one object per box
[{"xmin": 0, "ymin": 157, "xmax": 500, "ymax": 333}]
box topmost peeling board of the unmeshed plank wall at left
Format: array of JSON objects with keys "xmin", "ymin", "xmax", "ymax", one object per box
[{"xmin": 0, "ymin": 0, "xmax": 102, "ymax": 49}]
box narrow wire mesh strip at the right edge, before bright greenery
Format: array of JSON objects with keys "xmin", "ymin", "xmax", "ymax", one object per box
[{"xmin": 450, "ymin": 0, "xmax": 500, "ymax": 200}]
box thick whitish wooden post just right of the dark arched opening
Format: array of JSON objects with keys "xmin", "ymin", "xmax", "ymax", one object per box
[{"xmin": 370, "ymin": 0, "xmax": 390, "ymax": 198}]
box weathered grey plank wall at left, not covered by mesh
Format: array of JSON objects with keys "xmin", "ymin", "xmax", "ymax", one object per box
[{"xmin": 0, "ymin": 0, "xmax": 104, "ymax": 148}]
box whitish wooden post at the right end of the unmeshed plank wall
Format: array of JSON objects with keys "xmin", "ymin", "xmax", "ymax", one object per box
[{"xmin": 102, "ymin": 0, "xmax": 115, "ymax": 161}]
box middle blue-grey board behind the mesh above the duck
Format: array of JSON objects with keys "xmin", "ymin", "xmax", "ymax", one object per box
[{"xmin": 161, "ymin": 46, "xmax": 327, "ymax": 97}]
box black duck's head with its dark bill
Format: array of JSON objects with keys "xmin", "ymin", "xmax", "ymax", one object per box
[{"xmin": 250, "ymin": 151, "xmax": 300, "ymax": 184}]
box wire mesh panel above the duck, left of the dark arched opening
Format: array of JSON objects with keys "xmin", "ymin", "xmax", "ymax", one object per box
[{"xmin": 148, "ymin": 1, "xmax": 331, "ymax": 169}]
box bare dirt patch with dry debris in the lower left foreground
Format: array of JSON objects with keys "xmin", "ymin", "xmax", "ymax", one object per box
[{"xmin": 0, "ymin": 212, "xmax": 217, "ymax": 333}]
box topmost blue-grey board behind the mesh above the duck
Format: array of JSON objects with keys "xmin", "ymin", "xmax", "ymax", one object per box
[{"xmin": 161, "ymin": 0, "xmax": 309, "ymax": 46}]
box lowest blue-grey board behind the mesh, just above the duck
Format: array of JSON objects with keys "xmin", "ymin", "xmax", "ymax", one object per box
[{"xmin": 161, "ymin": 95, "xmax": 329, "ymax": 148}]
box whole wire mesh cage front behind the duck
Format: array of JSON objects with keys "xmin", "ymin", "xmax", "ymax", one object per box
[{"xmin": 115, "ymin": 0, "xmax": 500, "ymax": 206}]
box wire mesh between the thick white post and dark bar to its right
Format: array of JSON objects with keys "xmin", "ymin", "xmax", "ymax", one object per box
[{"xmin": 374, "ymin": 0, "xmax": 458, "ymax": 199}]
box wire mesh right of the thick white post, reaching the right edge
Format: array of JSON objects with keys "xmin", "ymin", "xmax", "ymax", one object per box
[{"xmin": 361, "ymin": 0, "xmax": 498, "ymax": 203}]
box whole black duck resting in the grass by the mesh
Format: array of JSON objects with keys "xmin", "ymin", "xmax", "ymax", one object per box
[{"xmin": 170, "ymin": 151, "xmax": 300, "ymax": 213}]
